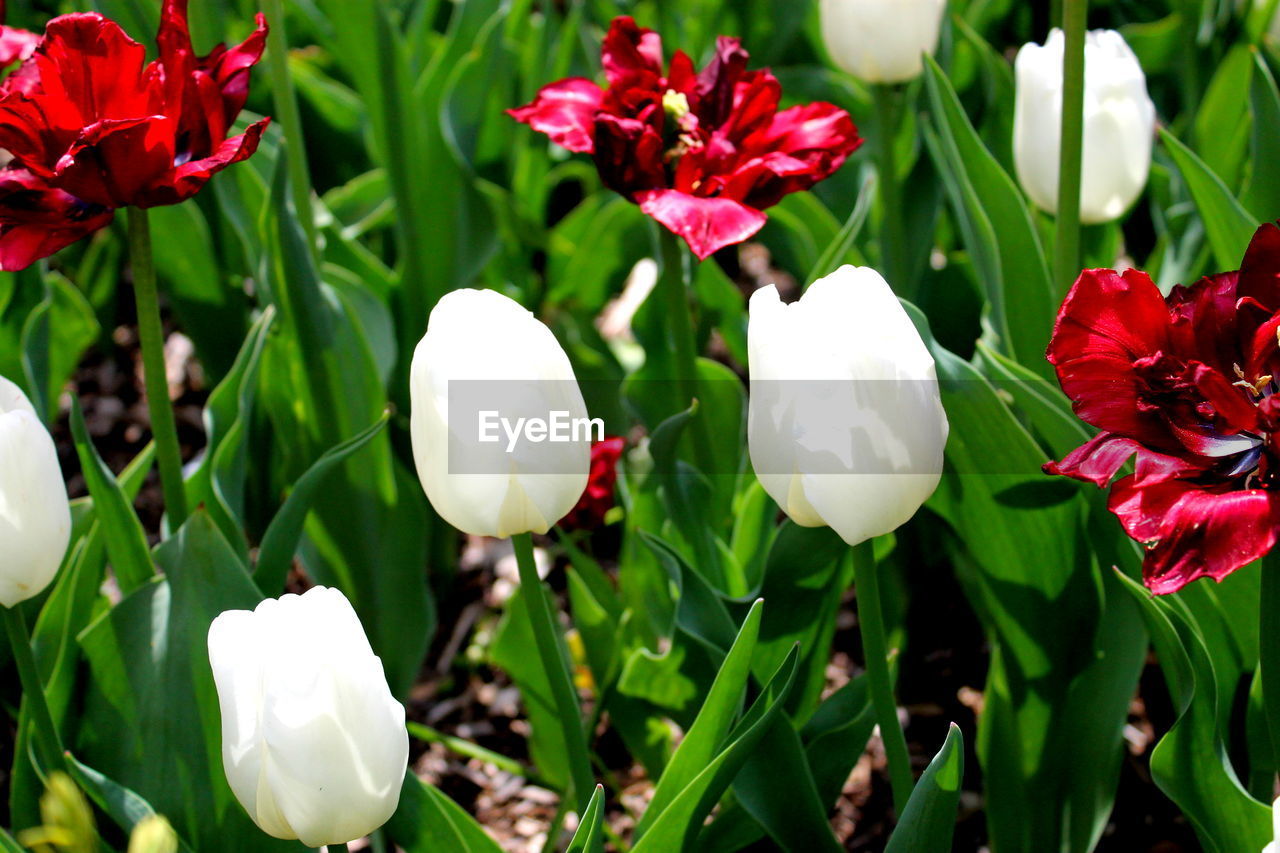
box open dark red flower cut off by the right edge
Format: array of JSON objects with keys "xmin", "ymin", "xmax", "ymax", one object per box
[{"xmin": 1044, "ymin": 224, "xmax": 1280, "ymax": 593}]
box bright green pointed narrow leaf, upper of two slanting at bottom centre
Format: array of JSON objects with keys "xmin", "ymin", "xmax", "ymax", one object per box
[{"xmin": 635, "ymin": 599, "xmax": 763, "ymax": 839}]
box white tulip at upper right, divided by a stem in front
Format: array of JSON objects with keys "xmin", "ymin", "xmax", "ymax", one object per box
[{"xmin": 1014, "ymin": 29, "xmax": 1156, "ymax": 224}]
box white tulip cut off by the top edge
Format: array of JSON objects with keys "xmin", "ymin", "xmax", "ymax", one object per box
[{"xmin": 822, "ymin": 0, "xmax": 947, "ymax": 83}]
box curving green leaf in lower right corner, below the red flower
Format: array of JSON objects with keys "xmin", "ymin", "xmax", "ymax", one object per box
[{"xmin": 1120, "ymin": 575, "xmax": 1272, "ymax": 853}]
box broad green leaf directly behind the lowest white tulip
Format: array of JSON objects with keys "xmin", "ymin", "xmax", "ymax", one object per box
[{"xmin": 69, "ymin": 510, "xmax": 303, "ymax": 852}]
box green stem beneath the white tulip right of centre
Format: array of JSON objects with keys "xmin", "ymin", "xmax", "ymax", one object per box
[{"xmin": 854, "ymin": 540, "xmax": 915, "ymax": 817}]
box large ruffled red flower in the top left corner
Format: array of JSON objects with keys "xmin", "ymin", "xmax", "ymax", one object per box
[{"xmin": 0, "ymin": 0, "xmax": 269, "ymax": 269}]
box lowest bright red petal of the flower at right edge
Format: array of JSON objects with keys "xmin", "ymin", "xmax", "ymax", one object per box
[{"xmin": 1143, "ymin": 485, "xmax": 1280, "ymax": 594}]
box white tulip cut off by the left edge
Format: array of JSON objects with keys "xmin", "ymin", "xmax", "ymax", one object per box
[{"xmin": 0, "ymin": 377, "xmax": 72, "ymax": 607}]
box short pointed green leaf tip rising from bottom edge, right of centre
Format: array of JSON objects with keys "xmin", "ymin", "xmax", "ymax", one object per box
[{"xmin": 884, "ymin": 722, "xmax": 964, "ymax": 853}]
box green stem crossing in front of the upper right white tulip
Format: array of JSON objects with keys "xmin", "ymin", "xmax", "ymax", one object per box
[{"xmin": 1053, "ymin": 0, "xmax": 1089, "ymax": 293}]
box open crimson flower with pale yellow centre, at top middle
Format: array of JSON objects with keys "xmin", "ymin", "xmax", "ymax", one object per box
[{"xmin": 508, "ymin": 18, "xmax": 861, "ymax": 259}]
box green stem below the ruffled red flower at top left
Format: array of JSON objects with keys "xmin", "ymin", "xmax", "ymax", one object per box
[{"xmin": 127, "ymin": 207, "xmax": 187, "ymax": 530}]
